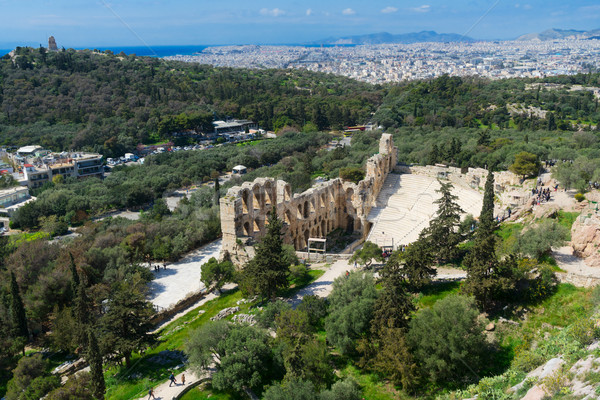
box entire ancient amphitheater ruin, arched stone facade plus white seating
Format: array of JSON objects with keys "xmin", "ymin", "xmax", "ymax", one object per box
[{"xmin": 220, "ymin": 134, "xmax": 526, "ymax": 263}]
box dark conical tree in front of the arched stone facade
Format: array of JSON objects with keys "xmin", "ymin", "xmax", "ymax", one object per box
[{"xmin": 242, "ymin": 207, "xmax": 289, "ymax": 300}]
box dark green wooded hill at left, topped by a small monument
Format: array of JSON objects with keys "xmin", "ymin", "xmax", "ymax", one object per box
[{"xmin": 0, "ymin": 48, "xmax": 383, "ymax": 157}]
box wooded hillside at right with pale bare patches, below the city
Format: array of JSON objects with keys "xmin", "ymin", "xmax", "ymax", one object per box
[{"xmin": 375, "ymin": 74, "xmax": 600, "ymax": 131}]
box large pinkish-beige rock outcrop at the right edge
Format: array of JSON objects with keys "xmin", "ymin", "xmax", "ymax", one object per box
[{"xmin": 571, "ymin": 214, "xmax": 600, "ymax": 268}]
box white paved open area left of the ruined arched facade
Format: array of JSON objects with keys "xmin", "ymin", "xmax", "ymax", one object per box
[{"xmin": 148, "ymin": 239, "xmax": 221, "ymax": 308}]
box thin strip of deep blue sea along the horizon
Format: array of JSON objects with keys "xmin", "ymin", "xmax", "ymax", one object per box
[{"xmin": 0, "ymin": 44, "xmax": 355, "ymax": 57}]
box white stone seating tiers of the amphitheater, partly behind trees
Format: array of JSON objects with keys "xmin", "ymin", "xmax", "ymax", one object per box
[{"xmin": 367, "ymin": 173, "xmax": 483, "ymax": 248}]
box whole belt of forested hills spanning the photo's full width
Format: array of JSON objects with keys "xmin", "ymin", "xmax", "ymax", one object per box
[{"xmin": 0, "ymin": 48, "xmax": 600, "ymax": 157}]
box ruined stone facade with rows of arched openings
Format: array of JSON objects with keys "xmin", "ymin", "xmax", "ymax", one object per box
[{"xmin": 220, "ymin": 134, "xmax": 397, "ymax": 253}]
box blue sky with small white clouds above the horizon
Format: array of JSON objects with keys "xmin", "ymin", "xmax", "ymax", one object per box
[{"xmin": 0, "ymin": 0, "xmax": 600, "ymax": 48}]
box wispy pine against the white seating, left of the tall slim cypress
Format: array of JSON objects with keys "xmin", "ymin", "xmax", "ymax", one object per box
[{"xmin": 422, "ymin": 182, "xmax": 463, "ymax": 263}]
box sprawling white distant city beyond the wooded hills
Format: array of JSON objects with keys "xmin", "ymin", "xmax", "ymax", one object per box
[{"xmin": 165, "ymin": 39, "xmax": 600, "ymax": 83}]
